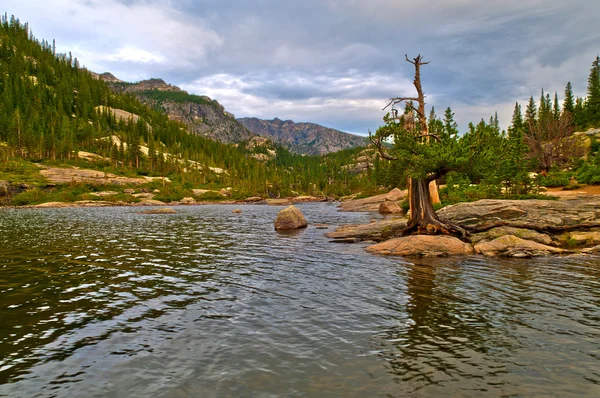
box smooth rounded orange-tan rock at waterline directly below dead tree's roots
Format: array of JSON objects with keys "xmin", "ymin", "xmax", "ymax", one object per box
[{"xmin": 367, "ymin": 235, "xmax": 474, "ymax": 257}]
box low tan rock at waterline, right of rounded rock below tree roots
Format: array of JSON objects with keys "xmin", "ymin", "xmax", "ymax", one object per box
[{"xmin": 475, "ymin": 235, "xmax": 566, "ymax": 258}]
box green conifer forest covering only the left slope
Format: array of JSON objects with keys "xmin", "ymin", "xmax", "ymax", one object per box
[{"xmin": 0, "ymin": 15, "xmax": 370, "ymax": 204}]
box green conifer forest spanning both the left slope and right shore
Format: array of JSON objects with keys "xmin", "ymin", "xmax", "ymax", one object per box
[{"xmin": 0, "ymin": 14, "xmax": 600, "ymax": 204}]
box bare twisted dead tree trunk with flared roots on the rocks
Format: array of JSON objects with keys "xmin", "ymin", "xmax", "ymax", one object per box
[{"xmin": 369, "ymin": 54, "xmax": 467, "ymax": 239}]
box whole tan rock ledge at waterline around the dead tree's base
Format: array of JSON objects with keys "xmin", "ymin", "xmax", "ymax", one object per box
[{"xmin": 326, "ymin": 197, "xmax": 600, "ymax": 258}]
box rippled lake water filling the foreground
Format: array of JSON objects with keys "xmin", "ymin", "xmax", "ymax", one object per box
[{"xmin": 0, "ymin": 203, "xmax": 600, "ymax": 397}]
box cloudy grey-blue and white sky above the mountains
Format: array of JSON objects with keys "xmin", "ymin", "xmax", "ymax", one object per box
[{"xmin": 5, "ymin": 0, "xmax": 600, "ymax": 134}]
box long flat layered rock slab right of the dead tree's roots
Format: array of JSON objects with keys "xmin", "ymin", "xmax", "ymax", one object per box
[{"xmin": 437, "ymin": 197, "xmax": 600, "ymax": 226}]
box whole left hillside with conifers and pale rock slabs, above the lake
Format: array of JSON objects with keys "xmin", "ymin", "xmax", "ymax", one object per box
[{"xmin": 0, "ymin": 17, "xmax": 380, "ymax": 204}]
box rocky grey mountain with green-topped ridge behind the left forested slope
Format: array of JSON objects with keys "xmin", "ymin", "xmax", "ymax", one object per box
[{"xmin": 95, "ymin": 73, "xmax": 254, "ymax": 143}]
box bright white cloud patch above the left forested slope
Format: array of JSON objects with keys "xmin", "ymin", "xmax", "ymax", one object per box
[{"xmin": 11, "ymin": 0, "xmax": 223, "ymax": 79}]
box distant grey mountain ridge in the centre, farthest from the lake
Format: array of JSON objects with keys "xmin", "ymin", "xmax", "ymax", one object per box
[{"xmin": 238, "ymin": 117, "xmax": 368, "ymax": 155}]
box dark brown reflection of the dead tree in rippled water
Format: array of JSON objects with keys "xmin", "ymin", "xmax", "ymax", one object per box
[{"xmin": 382, "ymin": 259, "xmax": 509, "ymax": 392}]
